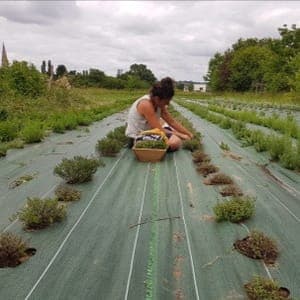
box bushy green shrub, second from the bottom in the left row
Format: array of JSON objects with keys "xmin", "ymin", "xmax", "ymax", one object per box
[{"xmin": 17, "ymin": 198, "xmax": 66, "ymax": 229}]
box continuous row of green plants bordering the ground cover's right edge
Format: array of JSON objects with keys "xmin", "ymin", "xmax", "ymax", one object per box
[{"xmin": 177, "ymin": 101, "xmax": 300, "ymax": 170}]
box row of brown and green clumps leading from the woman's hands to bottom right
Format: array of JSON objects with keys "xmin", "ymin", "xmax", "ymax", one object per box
[{"xmin": 179, "ymin": 116, "xmax": 290, "ymax": 300}]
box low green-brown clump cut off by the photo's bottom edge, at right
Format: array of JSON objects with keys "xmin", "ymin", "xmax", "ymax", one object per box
[{"xmin": 244, "ymin": 276, "xmax": 291, "ymax": 300}]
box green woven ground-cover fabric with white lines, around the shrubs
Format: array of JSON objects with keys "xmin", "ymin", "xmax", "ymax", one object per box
[{"xmin": 0, "ymin": 94, "xmax": 300, "ymax": 300}]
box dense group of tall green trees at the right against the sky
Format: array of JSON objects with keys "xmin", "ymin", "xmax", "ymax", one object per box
[{"xmin": 204, "ymin": 24, "xmax": 300, "ymax": 92}]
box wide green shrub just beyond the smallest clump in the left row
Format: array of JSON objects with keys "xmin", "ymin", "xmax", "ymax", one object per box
[{"xmin": 54, "ymin": 156, "xmax": 104, "ymax": 183}]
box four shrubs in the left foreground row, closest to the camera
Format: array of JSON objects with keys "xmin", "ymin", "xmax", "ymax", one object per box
[{"xmin": 0, "ymin": 152, "xmax": 104, "ymax": 268}]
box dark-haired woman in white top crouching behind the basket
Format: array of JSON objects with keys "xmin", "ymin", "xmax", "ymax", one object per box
[{"xmin": 126, "ymin": 77, "xmax": 193, "ymax": 151}]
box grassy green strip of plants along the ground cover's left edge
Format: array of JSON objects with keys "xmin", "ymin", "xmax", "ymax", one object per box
[{"xmin": 0, "ymin": 88, "xmax": 144, "ymax": 157}]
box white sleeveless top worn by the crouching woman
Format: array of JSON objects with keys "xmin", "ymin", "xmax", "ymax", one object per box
[{"xmin": 125, "ymin": 95, "xmax": 161, "ymax": 139}]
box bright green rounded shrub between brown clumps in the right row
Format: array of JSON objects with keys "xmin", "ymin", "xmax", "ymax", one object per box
[{"xmin": 213, "ymin": 197, "xmax": 255, "ymax": 223}]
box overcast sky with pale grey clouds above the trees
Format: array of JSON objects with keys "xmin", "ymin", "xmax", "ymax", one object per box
[{"xmin": 0, "ymin": 1, "xmax": 300, "ymax": 81}]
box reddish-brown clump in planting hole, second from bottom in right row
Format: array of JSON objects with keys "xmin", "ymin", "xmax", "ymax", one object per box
[{"xmin": 234, "ymin": 230, "xmax": 278, "ymax": 264}]
